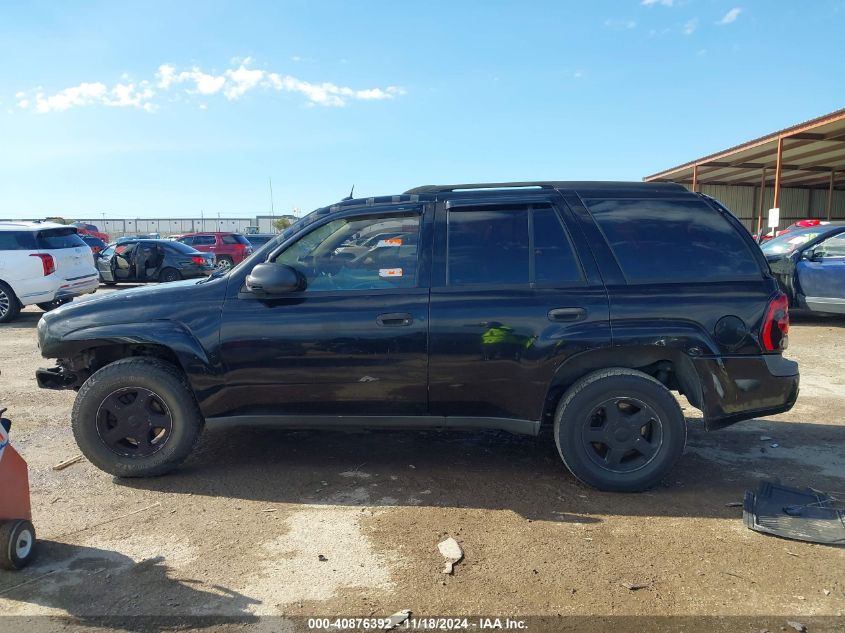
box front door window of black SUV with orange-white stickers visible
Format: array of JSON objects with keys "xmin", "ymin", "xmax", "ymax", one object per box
[{"xmin": 272, "ymin": 215, "xmax": 420, "ymax": 292}]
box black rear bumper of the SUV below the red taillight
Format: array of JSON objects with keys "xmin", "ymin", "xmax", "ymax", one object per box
[{"xmin": 693, "ymin": 354, "xmax": 799, "ymax": 430}]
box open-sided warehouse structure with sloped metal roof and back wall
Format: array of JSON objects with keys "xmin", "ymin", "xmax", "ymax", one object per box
[{"xmin": 644, "ymin": 109, "xmax": 845, "ymax": 233}]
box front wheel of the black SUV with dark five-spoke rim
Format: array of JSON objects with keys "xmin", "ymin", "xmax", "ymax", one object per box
[{"xmin": 71, "ymin": 357, "xmax": 203, "ymax": 477}]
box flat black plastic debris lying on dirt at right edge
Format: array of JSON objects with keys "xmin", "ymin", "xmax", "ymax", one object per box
[{"xmin": 742, "ymin": 481, "xmax": 845, "ymax": 545}]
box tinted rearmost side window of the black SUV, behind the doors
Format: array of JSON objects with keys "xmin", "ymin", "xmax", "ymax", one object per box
[{"xmin": 586, "ymin": 199, "xmax": 761, "ymax": 283}]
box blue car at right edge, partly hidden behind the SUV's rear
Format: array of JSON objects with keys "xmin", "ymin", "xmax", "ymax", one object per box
[{"xmin": 762, "ymin": 222, "xmax": 845, "ymax": 314}]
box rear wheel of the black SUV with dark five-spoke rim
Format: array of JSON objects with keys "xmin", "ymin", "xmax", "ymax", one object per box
[{"xmin": 554, "ymin": 367, "xmax": 687, "ymax": 492}]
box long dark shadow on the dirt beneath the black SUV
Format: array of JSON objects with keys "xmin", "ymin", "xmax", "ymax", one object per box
[{"xmin": 115, "ymin": 420, "xmax": 845, "ymax": 523}]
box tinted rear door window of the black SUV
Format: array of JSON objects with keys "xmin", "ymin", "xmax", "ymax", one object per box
[{"xmin": 447, "ymin": 204, "xmax": 583, "ymax": 286}]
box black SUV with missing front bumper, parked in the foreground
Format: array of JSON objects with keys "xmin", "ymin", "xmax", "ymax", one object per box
[{"xmin": 38, "ymin": 182, "xmax": 798, "ymax": 491}]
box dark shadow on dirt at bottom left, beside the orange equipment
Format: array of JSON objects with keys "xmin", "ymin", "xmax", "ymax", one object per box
[{"xmin": 0, "ymin": 541, "xmax": 258, "ymax": 632}]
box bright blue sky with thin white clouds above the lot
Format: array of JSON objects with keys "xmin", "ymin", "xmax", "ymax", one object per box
[{"xmin": 0, "ymin": 0, "xmax": 845, "ymax": 218}]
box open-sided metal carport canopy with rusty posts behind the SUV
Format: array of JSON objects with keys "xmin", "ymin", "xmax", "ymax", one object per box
[{"xmin": 643, "ymin": 108, "xmax": 845, "ymax": 229}]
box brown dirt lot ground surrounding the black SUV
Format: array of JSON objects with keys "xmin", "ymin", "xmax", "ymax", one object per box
[{"xmin": 0, "ymin": 286, "xmax": 845, "ymax": 632}]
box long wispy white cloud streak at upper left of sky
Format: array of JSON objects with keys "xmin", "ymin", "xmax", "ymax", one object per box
[{"xmin": 15, "ymin": 57, "xmax": 405, "ymax": 112}]
